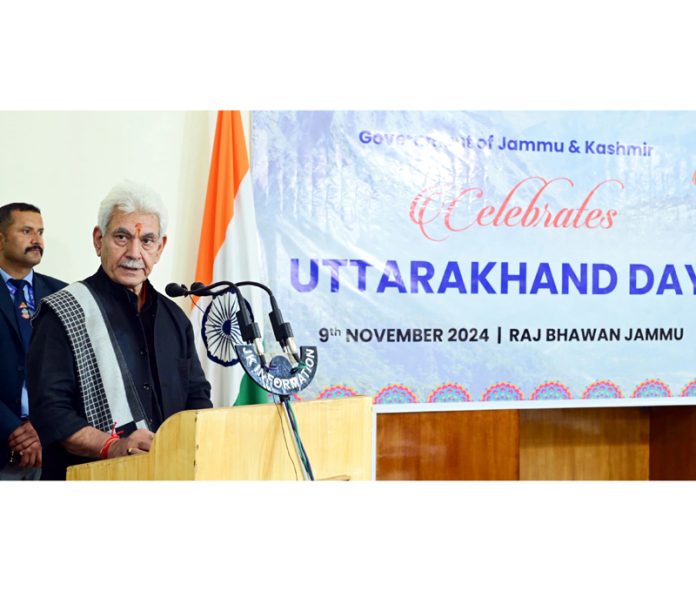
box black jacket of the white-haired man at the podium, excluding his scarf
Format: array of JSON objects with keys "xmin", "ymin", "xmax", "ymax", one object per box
[{"xmin": 27, "ymin": 267, "xmax": 212, "ymax": 480}]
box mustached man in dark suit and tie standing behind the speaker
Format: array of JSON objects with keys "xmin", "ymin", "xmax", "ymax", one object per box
[{"xmin": 0, "ymin": 203, "xmax": 66, "ymax": 480}]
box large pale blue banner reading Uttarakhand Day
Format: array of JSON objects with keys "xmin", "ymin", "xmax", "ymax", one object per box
[{"xmin": 252, "ymin": 112, "xmax": 696, "ymax": 408}]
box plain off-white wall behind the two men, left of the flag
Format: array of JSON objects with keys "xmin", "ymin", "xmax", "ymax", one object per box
[{"xmin": 0, "ymin": 111, "xmax": 215, "ymax": 309}]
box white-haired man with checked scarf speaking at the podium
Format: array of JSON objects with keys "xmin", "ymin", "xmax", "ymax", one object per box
[{"xmin": 27, "ymin": 182, "xmax": 212, "ymax": 480}]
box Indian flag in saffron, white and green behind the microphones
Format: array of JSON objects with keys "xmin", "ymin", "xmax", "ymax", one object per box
[{"xmin": 191, "ymin": 111, "xmax": 267, "ymax": 407}]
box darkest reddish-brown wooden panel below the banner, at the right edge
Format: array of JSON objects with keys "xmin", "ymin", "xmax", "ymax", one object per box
[{"xmin": 650, "ymin": 406, "xmax": 696, "ymax": 480}]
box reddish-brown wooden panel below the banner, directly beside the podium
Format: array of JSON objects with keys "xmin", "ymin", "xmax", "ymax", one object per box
[{"xmin": 376, "ymin": 410, "xmax": 519, "ymax": 480}]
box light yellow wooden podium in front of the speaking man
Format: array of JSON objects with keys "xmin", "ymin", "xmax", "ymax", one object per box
[{"xmin": 67, "ymin": 396, "xmax": 372, "ymax": 480}]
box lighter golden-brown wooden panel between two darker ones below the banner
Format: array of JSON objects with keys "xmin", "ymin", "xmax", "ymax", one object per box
[{"xmin": 520, "ymin": 408, "xmax": 650, "ymax": 480}]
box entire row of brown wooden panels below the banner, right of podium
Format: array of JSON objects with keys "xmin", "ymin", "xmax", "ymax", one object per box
[{"xmin": 376, "ymin": 406, "xmax": 696, "ymax": 480}]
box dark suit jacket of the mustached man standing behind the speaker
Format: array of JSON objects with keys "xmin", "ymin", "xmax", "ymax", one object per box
[{"xmin": 0, "ymin": 271, "xmax": 67, "ymax": 468}]
